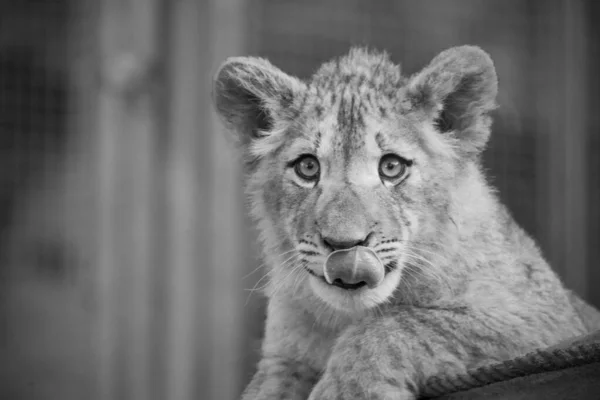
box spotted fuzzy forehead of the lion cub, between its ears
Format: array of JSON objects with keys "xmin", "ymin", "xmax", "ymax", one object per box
[{"xmin": 284, "ymin": 49, "xmax": 414, "ymax": 159}]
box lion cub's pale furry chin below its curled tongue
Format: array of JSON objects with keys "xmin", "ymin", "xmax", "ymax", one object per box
[{"xmin": 309, "ymin": 268, "xmax": 402, "ymax": 314}]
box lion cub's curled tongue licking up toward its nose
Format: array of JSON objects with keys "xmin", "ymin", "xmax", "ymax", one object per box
[{"xmin": 324, "ymin": 246, "xmax": 385, "ymax": 288}]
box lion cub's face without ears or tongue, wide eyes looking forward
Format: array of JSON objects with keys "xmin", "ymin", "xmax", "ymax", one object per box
[{"xmin": 264, "ymin": 90, "xmax": 454, "ymax": 310}]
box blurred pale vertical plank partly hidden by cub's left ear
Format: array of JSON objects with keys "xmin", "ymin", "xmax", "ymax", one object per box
[{"xmin": 209, "ymin": 0, "xmax": 248, "ymax": 400}]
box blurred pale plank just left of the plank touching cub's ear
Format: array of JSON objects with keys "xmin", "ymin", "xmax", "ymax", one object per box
[{"xmin": 165, "ymin": 0, "xmax": 205, "ymax": 400}]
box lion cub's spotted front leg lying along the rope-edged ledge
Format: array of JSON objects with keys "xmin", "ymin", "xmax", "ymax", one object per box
[{"xmin": 309, "ymin": 307, "xmax": 564, "ymax": 400}]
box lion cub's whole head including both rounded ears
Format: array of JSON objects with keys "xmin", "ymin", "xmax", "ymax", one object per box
[{"xmin": 213, "ymin": 46, "xmax": 497, "ymax": 312}]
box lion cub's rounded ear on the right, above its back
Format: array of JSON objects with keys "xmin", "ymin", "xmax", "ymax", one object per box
[{"xmin": 407, "ymin": 46, "xmax": 498, "ymax": 155}]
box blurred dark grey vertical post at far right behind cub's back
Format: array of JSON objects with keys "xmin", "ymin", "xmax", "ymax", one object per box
[{"xmin": 532, "ymin": 0, "xmax": 588, "ymax": 297}]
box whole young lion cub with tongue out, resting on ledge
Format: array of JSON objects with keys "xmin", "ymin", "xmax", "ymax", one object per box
[{"xmin": 213, "ymin": 46, "xmax": 584, "ymax": 400}]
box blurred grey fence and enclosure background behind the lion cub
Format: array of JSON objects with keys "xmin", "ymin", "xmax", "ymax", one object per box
[{"xmin": 0, "ymin": 0, "xmax": 600, "ymax": 400}]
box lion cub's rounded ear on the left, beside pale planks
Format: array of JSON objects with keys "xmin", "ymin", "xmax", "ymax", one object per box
[{"xmin": 212, "ymin": 57, "xmax": 306, "ymax": 153}]
